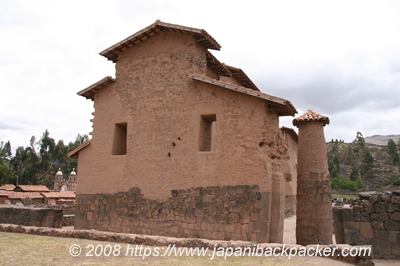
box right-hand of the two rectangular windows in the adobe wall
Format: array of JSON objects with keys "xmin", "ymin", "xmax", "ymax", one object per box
[{"xmin": 199, "ymin": 114, "xmax": 217, "ymax": 151}]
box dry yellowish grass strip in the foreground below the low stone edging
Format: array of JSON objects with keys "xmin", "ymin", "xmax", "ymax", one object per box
[{"xmin": 0, "ymin": 232, "xmax": 351, "ymax": 266}]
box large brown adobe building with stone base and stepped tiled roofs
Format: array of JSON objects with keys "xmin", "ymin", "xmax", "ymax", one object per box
[{"xmin": 69, "ymin": 20, "xmax": 297, "ymax": 243}]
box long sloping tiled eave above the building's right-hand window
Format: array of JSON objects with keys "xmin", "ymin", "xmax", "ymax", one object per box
[{"xmin": 189, "ymin": 75, "xmax": 297, "ymax": 116}]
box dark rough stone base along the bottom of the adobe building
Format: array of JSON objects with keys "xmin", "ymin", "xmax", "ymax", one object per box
[{"xmin": 75, "ymin": 185, "xmax": 269, "ymax": 241}]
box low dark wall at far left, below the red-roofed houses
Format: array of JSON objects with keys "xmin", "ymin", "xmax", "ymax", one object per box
[{"xmin": 0, "ymin": 205, "xmax": 63, "ymax": 228}]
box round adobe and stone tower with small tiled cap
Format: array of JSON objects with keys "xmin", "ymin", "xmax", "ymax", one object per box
[{"xmin": 293, "ymin": 110, "xmax": 332, "ymax": 245}]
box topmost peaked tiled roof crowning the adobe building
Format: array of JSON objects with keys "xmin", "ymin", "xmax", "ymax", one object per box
[{"xmin": 100, "ymin": 20, "xmax": 221, "ymax": 63}]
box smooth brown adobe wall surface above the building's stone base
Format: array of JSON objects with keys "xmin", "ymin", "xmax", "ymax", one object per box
[{"xmin": 76, "ymin": 31, "xmax": 294, "ymax": 242}]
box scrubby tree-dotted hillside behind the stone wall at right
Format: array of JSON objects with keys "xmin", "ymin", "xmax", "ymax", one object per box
[{"xmin": 327, "ymin": 134, "xmax": 400, "ymax": 190}]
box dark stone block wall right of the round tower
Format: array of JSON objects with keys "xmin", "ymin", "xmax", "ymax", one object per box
[{"xmin": 333, "ymin": 191, "xmax": 400, "ymax": 259}]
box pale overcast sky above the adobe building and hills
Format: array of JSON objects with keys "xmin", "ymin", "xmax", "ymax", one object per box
[{"xmin": 0, "ymin": 0, "xmax": 400, "ymax": 150}]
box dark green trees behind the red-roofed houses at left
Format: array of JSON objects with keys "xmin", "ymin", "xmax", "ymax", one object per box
[{"xmin": 0, "ymin": 129, "xmax": 89, "ymax": 188}]
